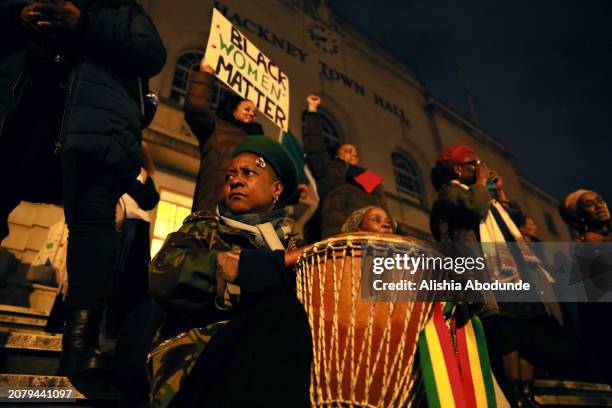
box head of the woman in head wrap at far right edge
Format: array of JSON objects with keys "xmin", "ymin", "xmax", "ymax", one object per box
[{"xmin": 559, "ymin": 189, "xmax": 612, "ymax": 242}]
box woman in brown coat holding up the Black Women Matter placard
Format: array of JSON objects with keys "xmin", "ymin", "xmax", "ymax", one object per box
[{"xmin": 183, "ymin": 64, "xmax": 263, "ymax": 212}]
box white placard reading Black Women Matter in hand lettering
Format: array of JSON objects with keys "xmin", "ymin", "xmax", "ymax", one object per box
[{"xmin": 200, "ymin": 9, "xmax": 289, "ymax": 131}]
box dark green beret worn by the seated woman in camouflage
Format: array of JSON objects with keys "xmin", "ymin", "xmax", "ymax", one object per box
[{"xmin": 232, "ymin": 135, "xmax": 297, "ymax": 207}]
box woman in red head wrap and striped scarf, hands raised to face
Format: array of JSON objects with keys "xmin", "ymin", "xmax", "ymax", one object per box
[{"xmin": 430, "ymin": 145, "xmax": 569, "ymax": 405}]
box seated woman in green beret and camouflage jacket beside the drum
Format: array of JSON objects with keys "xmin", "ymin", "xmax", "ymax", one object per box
[{"xmin": 149, "ymin": 136, "xmax": 312, "ymax": 408}]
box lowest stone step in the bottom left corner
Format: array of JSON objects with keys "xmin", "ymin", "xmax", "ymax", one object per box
[{"xmin": 0, "ymin": 374, "xmax": 119, "ymax": 408}]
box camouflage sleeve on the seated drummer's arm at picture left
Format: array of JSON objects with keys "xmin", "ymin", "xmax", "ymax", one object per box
[{"xmin": 149, "ymin": 217, "xmax": 217, "ymax": 304}]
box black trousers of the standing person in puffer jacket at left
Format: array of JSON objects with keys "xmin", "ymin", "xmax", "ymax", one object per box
[{"xmin": 0, "ymin": 87, "xmax": 121, "ymax": 308}]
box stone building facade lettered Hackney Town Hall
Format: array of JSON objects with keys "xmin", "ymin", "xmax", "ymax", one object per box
[{"xmin": 2, "ymin": 0, "xmax": 570, "ymax": 274}]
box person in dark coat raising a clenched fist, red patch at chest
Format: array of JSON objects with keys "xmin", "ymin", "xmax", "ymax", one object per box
[{"xmin": 302, "ymin": 95, "xmax": 385, "ymax": 242}]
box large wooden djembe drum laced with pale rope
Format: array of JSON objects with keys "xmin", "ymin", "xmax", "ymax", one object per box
[{"xmin": 296, "ymin": 233, "xmax": 438, "ymax": 407}]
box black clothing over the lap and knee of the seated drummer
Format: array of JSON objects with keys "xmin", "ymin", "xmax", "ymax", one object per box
[{"xmin": 171, "ymin": 293, "xmax": 312, "ymax": 408}]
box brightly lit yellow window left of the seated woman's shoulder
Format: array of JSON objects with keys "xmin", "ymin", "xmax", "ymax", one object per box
[{"xmin": 151, "ymin": 190, "xmax": 192, "ymax": 256}]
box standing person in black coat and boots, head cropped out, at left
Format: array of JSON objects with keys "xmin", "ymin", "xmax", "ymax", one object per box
[{"xmin": 0, "ymin": 0, "xmax": 166, "ymax": 376}]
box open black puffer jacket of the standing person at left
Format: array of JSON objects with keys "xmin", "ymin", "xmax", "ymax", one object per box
[{"xmin": 0, "ymin": 0, "xmax": 166, "ymax": 188}]
